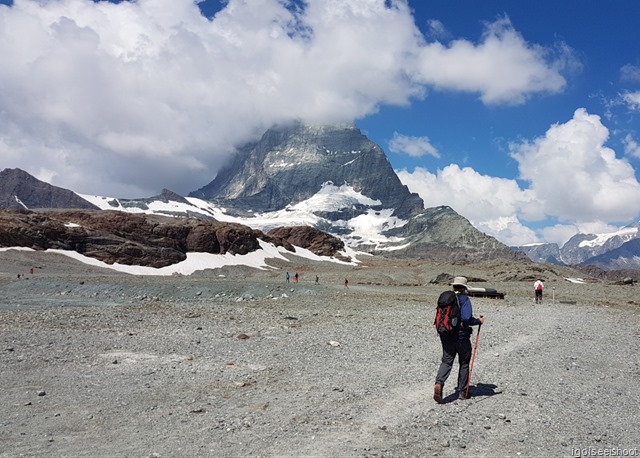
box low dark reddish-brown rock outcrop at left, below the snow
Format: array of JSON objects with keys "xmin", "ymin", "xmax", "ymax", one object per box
[{"xmin": 0, "ymin": 210, "xmax": 343, "ymax": 267}]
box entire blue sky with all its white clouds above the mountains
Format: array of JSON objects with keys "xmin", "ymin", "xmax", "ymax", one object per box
[{"xmin": 0, "ymin": 0, "xmax": 640, "ymax": 245}]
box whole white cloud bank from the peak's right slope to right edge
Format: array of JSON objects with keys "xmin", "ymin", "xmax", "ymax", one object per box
[{"xmin": 398, "ymin": 108, "xmax": 640, "ymax": 245}]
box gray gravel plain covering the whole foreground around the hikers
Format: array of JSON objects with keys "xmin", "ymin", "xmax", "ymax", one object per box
[{"xmin": 0, "ymin": 252, "xmax": 640, "ymax": 457}]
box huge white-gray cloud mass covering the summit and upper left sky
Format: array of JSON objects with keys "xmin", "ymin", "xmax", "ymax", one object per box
[{"xmin": 0, "ymin": 0, "xmax": 565, "ymax": 197}]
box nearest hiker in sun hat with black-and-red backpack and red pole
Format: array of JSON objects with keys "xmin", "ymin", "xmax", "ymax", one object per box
[{"xmin": 433, "ymin": 277, "xmax": 484, "ymax": 404}]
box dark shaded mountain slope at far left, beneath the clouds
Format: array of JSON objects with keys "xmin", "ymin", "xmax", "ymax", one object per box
[{"xmin": 0, "ymin": 169, "xmax": 98, "ymax": 210}]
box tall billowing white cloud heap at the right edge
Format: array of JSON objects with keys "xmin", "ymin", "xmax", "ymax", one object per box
[{"xmin": 512, "ymin": 108, "xmax": 640, "ymax": 223}]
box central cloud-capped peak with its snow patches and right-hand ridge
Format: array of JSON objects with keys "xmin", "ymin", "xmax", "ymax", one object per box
[{"xmin": 189, "ymin": 123, "xmax": 524, "ymax": 259}]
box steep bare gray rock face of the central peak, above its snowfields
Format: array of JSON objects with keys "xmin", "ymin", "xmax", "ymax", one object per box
[{"xmin": 189, "ymin": 123, "xmax": 424, "ymax": 218}]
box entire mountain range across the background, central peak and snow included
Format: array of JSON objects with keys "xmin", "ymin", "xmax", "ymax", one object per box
[{"xmin": 0, "ymin": 123, "xmax": 640, "ymax": 270}]
